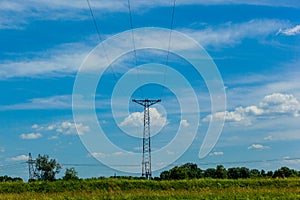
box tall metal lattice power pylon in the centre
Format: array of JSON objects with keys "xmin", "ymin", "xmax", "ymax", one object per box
[{"xmin": 132, "ymin": 99, "xmax": 161, "ymax": 179}]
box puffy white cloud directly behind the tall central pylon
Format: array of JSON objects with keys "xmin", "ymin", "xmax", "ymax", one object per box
[{"xmin": 119, "ymin": 108, "xmax": 167, "ymax": 127}]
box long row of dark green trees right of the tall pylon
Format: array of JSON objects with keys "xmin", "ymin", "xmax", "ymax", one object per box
[{"xmin": 159, "ymin": 163, "xmax": 300, "ymax": 180}]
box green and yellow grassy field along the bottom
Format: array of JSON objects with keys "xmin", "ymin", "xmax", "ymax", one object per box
[{"xmin": 0, "ymin": 178, "xmax": 300, "ymax": 199}]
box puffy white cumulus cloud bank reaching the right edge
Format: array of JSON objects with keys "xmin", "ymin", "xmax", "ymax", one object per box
[{"xmin": 203, "ymin": 93, "xmax": 300, "ymax": 125}]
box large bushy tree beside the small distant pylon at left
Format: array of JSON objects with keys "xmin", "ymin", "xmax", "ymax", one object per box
[{"xmin": 35, "ymin": 155, "xmax": 61, "ymax": 181}]
